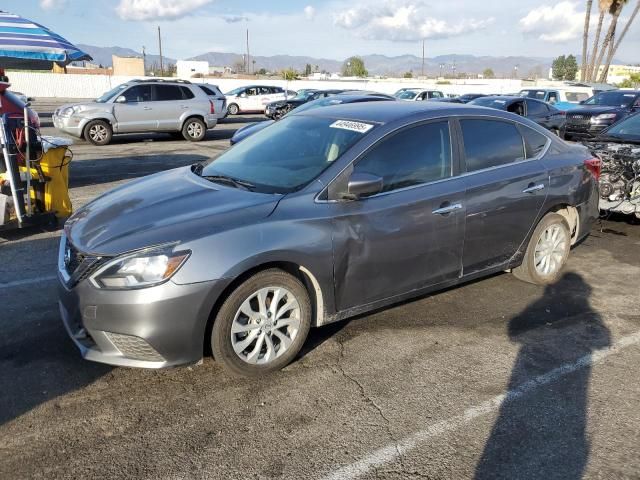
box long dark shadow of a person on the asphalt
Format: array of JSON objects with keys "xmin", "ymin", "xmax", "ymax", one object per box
[{"xmin": 474, "ymin": 273, "xmax": 611, "ymax": 480}]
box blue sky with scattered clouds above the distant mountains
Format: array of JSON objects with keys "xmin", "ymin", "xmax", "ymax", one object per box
[{"xmin": 1, "ymin": 0, "xmax": 640, "ymax": 63}]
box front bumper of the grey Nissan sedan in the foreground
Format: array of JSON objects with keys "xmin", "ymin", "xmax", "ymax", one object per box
[{"xmin": 58, "ymin": 239, "xmax": 224, "ymax": 368}]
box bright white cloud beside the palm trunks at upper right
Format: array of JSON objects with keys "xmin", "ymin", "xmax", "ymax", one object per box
[{"xmin": 520, "ymin": 1, "xmax": 584, "ymax": 43}]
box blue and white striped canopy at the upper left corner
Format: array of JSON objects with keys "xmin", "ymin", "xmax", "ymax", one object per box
[{"xmin": 0, "ymin": 11, "xmax": 92, "ymax": 70}]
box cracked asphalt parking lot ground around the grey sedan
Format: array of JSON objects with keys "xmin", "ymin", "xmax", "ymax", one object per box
[{"xmin": 0, "ymin": 104, "xmax": 640, "ymax": 479}]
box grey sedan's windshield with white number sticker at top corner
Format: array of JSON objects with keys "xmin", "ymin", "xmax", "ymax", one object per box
[{"xmin": 202, "ymin": 115, "xmax": 373, "ymax": 193}]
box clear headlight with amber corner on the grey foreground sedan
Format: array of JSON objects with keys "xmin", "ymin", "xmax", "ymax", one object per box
[{"xmin": 90, "ymin": 248, "xmax": 191, "ymax": 290}]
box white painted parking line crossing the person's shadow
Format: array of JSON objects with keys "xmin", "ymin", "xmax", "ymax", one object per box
[{"xmin": 324, "ymin": 332, "xmax": 640, "ymax": 480}]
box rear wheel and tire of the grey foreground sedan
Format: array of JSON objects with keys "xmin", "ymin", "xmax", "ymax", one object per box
[{"xmin": 513, "ymin": 213, "xmax": 571, "ymax": 285}]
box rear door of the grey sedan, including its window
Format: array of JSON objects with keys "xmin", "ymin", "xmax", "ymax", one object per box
[{"xmin": 460, "ymin": 118, "xmax": 549, "ymax": 275}]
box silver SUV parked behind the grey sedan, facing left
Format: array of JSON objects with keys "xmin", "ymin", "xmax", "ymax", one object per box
[{"xmin": 53, "ymin": 80, "xmax": 226, "ymax": 145}]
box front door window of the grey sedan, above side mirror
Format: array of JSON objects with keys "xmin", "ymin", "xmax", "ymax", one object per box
[{"xmin": 354, "ymin": 121, "xmax": 451, "ymax": 192}]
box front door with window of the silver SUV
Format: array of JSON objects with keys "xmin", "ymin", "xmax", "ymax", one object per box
[{"xmin": 113, "ymin": 85, "xmax": 157, "ymax": 133}]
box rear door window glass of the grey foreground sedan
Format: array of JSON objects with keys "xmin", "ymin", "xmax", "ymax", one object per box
[{"xmin": 460, "ymin": 119, "xmax": 524, "ymax": 172}]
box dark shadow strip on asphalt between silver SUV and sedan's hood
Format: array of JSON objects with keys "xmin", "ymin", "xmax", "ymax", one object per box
[{"xmin": 69, "ymin": 152, "xmax": 214, "ymax": 188}]
